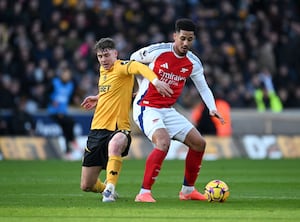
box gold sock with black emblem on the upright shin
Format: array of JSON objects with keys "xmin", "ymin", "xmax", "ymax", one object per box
[{"xmin": 106, "ymin": 156, "xmax": 122, "ymax": 186}]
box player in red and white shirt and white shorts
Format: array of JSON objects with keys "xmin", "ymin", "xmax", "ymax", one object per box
[{"xmin": 130, "ymin": 18, "xmax": 224, "ymax": 202}]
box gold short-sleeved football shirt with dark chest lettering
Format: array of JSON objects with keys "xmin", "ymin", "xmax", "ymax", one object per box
[{"xmin": 91, "ymin": 60, "xmax": 157, "ymax": 131}]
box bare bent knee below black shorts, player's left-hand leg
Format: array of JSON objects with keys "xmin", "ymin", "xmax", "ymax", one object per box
[{"xmin": 81, "ymin": 166, "xmax": 101, "ymax": 187}]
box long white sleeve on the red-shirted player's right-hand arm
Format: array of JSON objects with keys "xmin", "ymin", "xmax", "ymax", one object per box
[{"xmin": 191, "ymin": 66, "xmax": 217, "ymax": 111}]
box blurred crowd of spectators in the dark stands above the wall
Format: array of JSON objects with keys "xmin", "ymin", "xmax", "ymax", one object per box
[{"xmin": 0, "ymin": 0, "xmax": 300, "ymax": 112}]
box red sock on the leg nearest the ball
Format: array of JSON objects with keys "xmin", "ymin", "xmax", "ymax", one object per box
[{"xmin": 183, "ymin": 148, "xmax": 204, "ymax": 186}]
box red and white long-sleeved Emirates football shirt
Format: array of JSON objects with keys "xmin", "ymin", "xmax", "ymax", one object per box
[{"xmin": 130, "ymin": 43, "xmax": 216, "ymax": 110}]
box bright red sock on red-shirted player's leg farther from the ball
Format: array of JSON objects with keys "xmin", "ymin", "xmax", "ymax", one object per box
[{"xmin": 142, "ymin": 148, "xmax": 167, "ymax": 190}]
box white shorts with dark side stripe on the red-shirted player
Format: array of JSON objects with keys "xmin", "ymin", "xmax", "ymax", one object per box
[{"xmin": 133, "ymin": 103, "xmax": 194, "ymax": 142}]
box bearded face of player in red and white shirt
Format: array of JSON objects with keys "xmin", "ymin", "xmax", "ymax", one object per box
[{"xmin": 173, "ymin": 30, "xmax": 195, "ymax": 56}]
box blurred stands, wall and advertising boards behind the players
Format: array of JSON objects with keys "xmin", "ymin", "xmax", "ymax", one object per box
[{"xmin": 0, "ymin": 0, "xmax": 300, "ymax": 159}]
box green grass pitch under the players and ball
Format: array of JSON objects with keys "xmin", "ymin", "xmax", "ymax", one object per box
[{"xmin": 0, "ymin": 159, "xmax": 300, "ymax": 222}]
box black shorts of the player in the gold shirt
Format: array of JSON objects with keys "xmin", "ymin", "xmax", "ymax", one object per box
[{"xmin": 82, "ymin": 129, "xmax": 131, "ymax": 169}]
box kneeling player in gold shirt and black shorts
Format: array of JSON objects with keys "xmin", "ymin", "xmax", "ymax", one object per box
[{"xmin": 80, "ymin": 38, "xmax": 173, "ymax": 202}]
